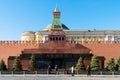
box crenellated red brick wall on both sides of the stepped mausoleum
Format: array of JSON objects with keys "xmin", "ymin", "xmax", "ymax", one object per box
[{"xmin": 0, "ymin": 41, "xmax": 120, "ymax": 66}]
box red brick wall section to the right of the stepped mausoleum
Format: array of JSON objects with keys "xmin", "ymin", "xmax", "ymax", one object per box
[{"xmin": 80, "ymin": 42, "xmax": 120, "ymax": 66}]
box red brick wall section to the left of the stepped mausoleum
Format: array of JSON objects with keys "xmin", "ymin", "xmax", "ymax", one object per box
[{"xmin": 0, "ymin": 43, "xmax": 39, "ymax": 67}]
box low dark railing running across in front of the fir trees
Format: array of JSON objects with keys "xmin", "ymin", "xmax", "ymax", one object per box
[{"xmin": 0, "ymin": 69, "xmax": 120, "ymax": 75}]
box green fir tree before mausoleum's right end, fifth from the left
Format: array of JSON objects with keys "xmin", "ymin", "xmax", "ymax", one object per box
[{"xmin": 90, "ymin": 55, "xmax": 99, "ymax": 71}]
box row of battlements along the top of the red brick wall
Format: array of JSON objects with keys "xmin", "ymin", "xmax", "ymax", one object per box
[{"xmin": 0, "ymin": 40, "xmax": 120, "ymax": 45}]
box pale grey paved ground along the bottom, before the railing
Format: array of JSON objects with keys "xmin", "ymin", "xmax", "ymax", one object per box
[{"xmin": 0, "ymin": 75, "xmax": 120, "ymax": 80}]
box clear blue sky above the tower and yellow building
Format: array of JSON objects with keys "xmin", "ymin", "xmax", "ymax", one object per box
[{"xmin": 0, "ymin": 0, "xmax": 120, "ymax": 40}]
